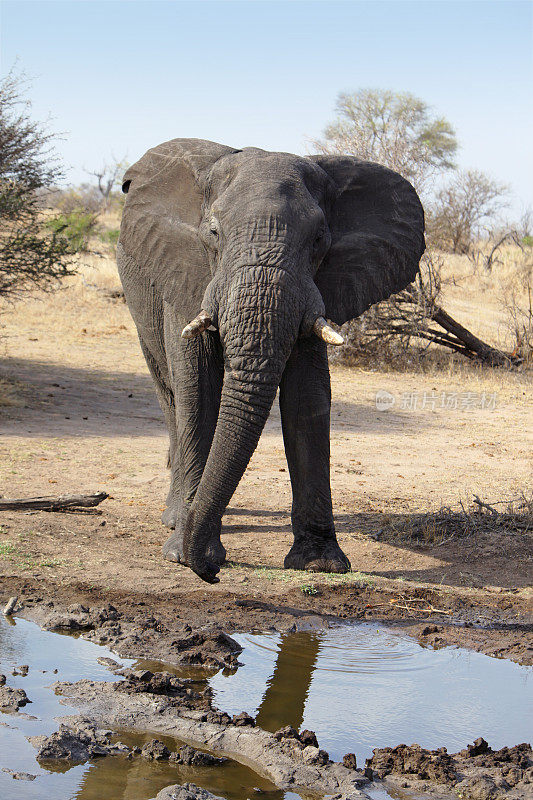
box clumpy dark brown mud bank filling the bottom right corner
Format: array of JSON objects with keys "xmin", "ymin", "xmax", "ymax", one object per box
[{"xmin": 366, "ymin": 738, "xmax": 533, "ymax": 800}]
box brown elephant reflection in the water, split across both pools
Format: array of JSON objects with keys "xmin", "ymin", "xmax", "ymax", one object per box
[{"xmin": 75, "ymin": 632, "xmax": 320, "ymax": 800}]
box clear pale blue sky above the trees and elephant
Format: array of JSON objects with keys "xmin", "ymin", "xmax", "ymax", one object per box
[{"xmin": 1, "ymin": 0, "xmax": 533, "ymax": 213}]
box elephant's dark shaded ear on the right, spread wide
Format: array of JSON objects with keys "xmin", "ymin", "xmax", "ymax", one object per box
[{"xmin": 310, "ymin": 155, "xmax": 425, "ymax": 325}]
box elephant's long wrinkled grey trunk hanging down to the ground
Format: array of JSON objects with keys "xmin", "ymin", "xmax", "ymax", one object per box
[{"xmin": 183, "ymin": 266, "xmax": 321, "ymax": 583}]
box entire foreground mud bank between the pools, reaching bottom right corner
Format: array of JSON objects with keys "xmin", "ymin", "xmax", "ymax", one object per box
[{"xmin": 33, "ymin": 669, "xmax": 533, "ymax": 800}]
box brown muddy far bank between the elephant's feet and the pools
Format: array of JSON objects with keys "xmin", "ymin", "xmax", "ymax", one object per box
[{"xmin": 11, "ymin": 581, "xmax": 533, "ymax": 668}]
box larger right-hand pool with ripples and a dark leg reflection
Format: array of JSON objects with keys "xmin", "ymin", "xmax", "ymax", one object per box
[{"xmin": 210, "ymin": 624, "xmax": 533, "ymax": 766}]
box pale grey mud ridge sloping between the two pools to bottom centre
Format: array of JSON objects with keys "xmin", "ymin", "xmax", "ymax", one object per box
[{"xmin": 54, "ymin": 670, "xmax": 368, "ymax": 798}]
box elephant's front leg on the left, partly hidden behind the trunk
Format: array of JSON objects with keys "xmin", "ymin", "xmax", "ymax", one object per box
[{"xmin": 159, "ymin": 309, "xmax": 226, "ymax": 565}]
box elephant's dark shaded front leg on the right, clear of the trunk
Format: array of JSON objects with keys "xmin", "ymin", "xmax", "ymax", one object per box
[{"xmin": 280, "ymin": 336, "xmax": 350, "ymax": 572}]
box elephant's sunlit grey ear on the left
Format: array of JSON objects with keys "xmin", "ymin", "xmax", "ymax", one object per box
[{"xmin": 119, "ymin": 139, "xmax": 238, "ymax": 316}]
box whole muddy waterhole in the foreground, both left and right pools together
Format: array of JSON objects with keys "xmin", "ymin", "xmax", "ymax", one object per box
[{"xmin": 0, "ymin": 617, "xmax": 533, "ymax": 800}]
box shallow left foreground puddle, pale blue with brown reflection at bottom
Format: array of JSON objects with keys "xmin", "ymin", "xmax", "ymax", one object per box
[{"xmin": 0, "ymin": 615, "xmax": 300, "ymax": 800}]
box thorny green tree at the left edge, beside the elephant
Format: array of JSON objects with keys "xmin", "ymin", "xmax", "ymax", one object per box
[{"xmin": 0, "ymin": 71, "xmax": 73, "ymax": 297}]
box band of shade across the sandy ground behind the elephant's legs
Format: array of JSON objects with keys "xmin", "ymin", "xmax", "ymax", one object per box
[{"xmin": 0, "ymin": 358, "xmax": 430, "ymax": 438}]
